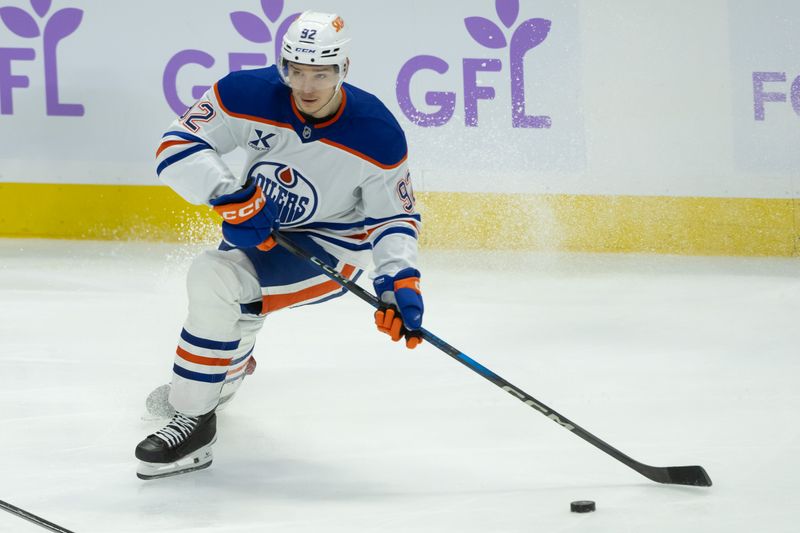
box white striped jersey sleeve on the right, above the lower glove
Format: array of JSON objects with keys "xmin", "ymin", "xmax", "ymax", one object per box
[{"xmin": 361, "ymin": 161, "xmax": 421, "ymax": 276}]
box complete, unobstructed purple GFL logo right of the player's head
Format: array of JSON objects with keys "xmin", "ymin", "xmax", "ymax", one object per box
[{"xmin": 396, "ymin": 0, "xmax": 552, "ymax": 128}]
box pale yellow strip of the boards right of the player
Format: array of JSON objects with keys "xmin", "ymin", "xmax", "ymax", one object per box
[{"xmin": 418, "ymin": 193, "xmax": 800, "ymax": 257}]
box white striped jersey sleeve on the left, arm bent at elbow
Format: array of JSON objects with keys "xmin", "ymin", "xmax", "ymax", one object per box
[{"xmin": 156, "ymin": 84, "xmax": 244, "ymax": 204}]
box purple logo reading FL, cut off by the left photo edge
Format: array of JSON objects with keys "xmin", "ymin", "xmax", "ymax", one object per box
[{"xmin": 0, "ymin": 0, "xmax": 84, "ymax": 117}]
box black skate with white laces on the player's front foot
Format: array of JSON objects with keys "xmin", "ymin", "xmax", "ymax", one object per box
[{"xmin": 136, "ymin": 411, "xmax": 217, "ymax": 479}]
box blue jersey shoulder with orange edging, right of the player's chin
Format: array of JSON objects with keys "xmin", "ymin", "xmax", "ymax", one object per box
[{"xmin": 330, "ymin": 83, "xmax": 408, "ymax": 168}]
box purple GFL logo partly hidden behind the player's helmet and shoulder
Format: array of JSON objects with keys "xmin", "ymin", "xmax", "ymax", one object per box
[{"xmin": 162, "ymin": 0, "xmax": 300, "ymax": 115}]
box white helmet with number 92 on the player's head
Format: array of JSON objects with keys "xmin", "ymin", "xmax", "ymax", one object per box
[{"xmin": 278, "ymin": 11, "xmax": 350, "ymax": 90}]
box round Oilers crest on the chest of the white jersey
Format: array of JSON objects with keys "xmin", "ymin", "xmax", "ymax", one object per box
[{"xmin": 247, "ymin": 161, "xmax": 318, "ymax": 227}]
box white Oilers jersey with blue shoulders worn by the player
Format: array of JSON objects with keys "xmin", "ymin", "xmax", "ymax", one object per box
[{"xmin": 157, "ymin": 66, "xmax": 420, "ymax": 275}]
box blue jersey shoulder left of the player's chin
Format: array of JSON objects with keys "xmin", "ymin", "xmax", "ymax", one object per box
[{"xmin": 215, "ymin": 65, "xmax": 289, "ymax": 120}]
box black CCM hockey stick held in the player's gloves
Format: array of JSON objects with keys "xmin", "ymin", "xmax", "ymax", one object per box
[{"xmin": 272, "ymin": 231, "xmax": 711, "ymax": 487}]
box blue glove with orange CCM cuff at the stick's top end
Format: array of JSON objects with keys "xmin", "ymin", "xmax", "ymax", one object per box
[{"xmin": 211, "ymin": 183, "xmax": 280, "ymax": 251}]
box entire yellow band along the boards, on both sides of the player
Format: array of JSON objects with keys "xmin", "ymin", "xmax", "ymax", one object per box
[{"xmin": 0, "ymin": 183, "xmax": 800, "ymax": 257}]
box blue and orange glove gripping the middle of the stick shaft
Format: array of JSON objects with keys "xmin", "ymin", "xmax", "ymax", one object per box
[{"xmin": 373, "ymin": 268, "xmax": 425, "ymax": 349}]
